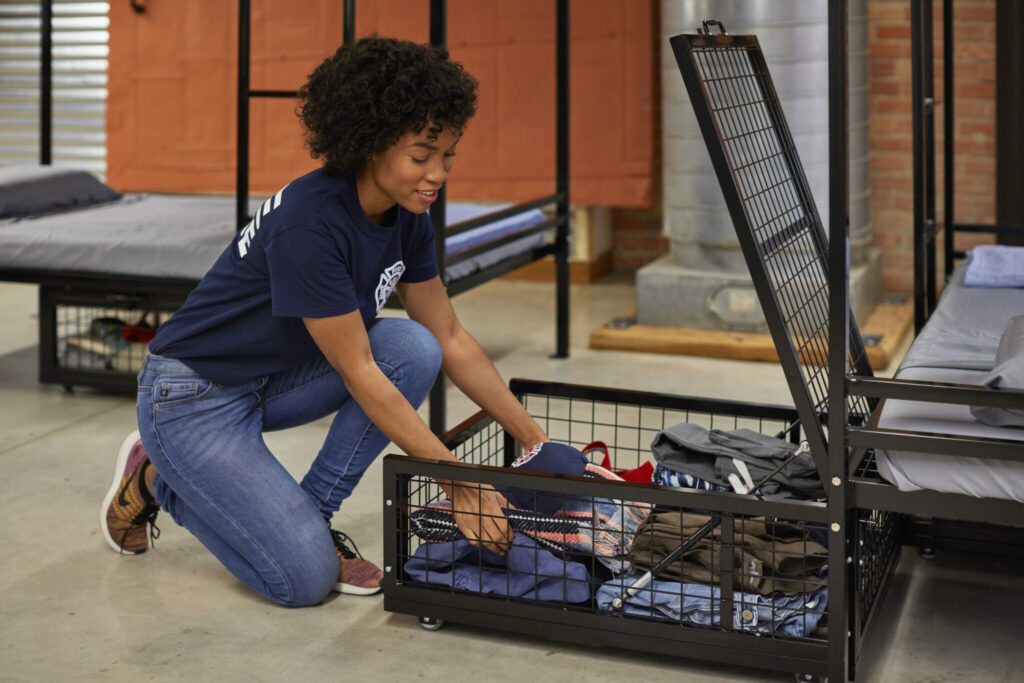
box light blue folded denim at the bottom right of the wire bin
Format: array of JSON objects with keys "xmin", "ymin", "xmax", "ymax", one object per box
[{"xmin": 595, "ymin": 571, "xmax": 828, "ymax": 637}]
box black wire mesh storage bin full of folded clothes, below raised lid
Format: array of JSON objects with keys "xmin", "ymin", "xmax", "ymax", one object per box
[{"xmin": 384, "ymin": 380, "xmax": 899, "ymax": 677}]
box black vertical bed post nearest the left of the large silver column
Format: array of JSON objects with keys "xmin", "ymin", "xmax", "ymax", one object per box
[{"xmin": 554, "ymin": 0, "xmax": 569, "ymax": 358}]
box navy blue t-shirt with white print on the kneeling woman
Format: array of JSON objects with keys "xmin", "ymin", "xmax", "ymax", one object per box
[{"xmin": 150, "ymin": 170, "xmax": 437, "ymax": 385}]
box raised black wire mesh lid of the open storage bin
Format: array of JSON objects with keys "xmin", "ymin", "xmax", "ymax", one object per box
[{"xmin": 672, "ymin": 35, "xmax": 872, "ymax": 450}]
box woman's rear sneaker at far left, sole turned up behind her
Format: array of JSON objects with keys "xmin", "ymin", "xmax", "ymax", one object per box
[{"xmin": 99, "ymin": 431, "xmax": 160, "ymax": 555}]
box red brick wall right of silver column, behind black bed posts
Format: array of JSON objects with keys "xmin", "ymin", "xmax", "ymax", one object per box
[{"xmin": 868, "ymin": 0, "xmax": 995, "ymax": 292}]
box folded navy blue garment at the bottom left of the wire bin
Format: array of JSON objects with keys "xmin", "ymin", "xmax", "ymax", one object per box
[{"xmin": 404, "ymin": 535, "xmax": 590, "ymax": 602}]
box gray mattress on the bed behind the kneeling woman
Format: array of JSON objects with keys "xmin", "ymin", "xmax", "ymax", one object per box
[{"xmin": 0, "ymin": 195, "xmax": 544, "ymax": 282}]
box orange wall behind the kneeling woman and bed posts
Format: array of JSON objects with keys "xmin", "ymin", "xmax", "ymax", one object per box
[{"xmin": 106, "ymin": 0, "xmax": 657, "ymax": 208}]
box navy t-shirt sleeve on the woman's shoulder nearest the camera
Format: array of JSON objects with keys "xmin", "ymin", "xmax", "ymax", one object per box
[{"xmin": 264, "ymin": 226, "xmax": 358, "ymax": 317}]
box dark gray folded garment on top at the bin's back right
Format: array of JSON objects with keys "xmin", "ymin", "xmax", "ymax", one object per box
[{"xmin": 650, "ymin": 422, "xmax": 825, "ymax": 500}]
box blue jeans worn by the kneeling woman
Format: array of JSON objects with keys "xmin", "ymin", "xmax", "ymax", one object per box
[{"xmin": 138, "ymin": 318, "xmax": 441, "ymax": 606}]
